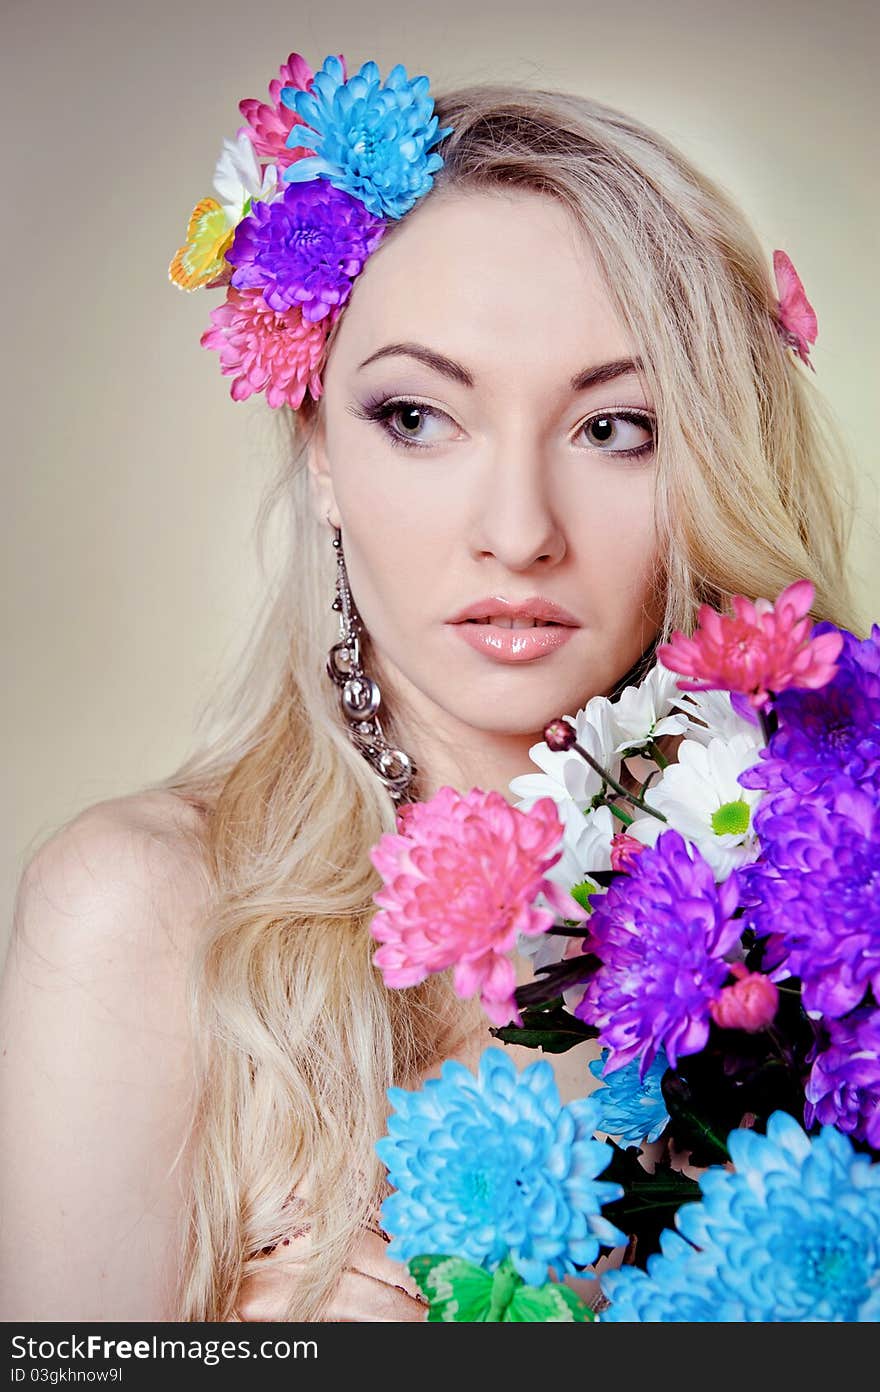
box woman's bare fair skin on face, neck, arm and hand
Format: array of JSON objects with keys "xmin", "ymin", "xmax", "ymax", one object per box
[{"xmin": 0, "ymin": 193, "xmax": 660, "ymax": 1321}]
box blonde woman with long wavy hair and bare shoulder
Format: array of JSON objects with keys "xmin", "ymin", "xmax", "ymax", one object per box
[{"xmin": 3, "ymin": 57, "xmax": 856, "ymax": 1320}]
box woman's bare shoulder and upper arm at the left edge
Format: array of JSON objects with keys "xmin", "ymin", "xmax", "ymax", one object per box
[{"xmin": 0, "ymin": 792, "xmax": 209, "ymax": 1321}]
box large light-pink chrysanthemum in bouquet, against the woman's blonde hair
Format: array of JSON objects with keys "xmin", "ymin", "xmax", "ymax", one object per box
[{"xmin": 370, "ymin": 788, "xmax": 586, "ymax": 1025}]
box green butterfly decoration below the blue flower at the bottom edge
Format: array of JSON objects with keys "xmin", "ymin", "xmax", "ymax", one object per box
[{"xmin": 407, "ymin": 1256, "xmax": 595, "ymax": 1324}]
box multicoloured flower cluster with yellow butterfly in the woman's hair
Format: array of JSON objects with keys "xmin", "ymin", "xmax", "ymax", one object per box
[{"xmin": 168, "ymin": 53, "xmax": 451, "ymax": 409}]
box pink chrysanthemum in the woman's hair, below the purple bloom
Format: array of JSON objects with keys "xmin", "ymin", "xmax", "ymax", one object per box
[{"xmin": 199, "ymin": 287, "xmax": 334, "ymax": 409}]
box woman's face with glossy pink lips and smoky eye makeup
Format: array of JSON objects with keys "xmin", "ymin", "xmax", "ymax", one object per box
[{"xmin": 309, "ymin": 192, "xmax": 660, "ymax": 742}]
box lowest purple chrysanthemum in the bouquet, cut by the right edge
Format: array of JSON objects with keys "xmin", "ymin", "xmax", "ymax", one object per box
[{"xmin": 803, "ymin": 1006, "xmax": 880, "ymax": 1150}]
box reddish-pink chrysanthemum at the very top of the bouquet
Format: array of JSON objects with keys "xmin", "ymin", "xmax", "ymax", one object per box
[{"xmin": 657, "ymin": 580, "xmax": 844, "ymax": 709}]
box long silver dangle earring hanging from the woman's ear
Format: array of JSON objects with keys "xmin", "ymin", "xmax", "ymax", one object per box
[{"xmin": 327, "ymin": 528, "xmax": 416, "ymax": 802}]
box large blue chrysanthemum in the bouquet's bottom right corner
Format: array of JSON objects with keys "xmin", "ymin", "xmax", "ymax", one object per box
[{"xmin": 600, "ymin": 1112, "xmax": 880, "ymax": 1324}]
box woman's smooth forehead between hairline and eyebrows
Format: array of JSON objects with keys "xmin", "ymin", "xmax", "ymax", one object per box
[{"xmin": 333, "ymin": 191, "xmax": 634, "ymax": 380}]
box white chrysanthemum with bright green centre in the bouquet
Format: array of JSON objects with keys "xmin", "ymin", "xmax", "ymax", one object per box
[{"xmin": 627, "ymin": 734, "xmax": 762, "ymax": 881}]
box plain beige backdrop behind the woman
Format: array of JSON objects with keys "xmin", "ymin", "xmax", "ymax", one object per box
[{"xmin": 0, "ymin": 0, "xmax": 880, "ymax": 945}]
